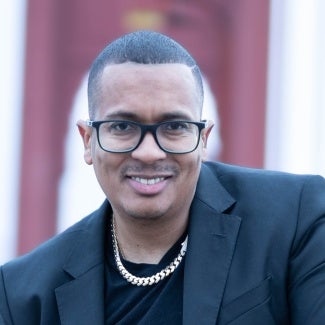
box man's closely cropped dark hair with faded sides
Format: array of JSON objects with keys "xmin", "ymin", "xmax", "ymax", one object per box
[{"xmin": 88, "ymin": 30, "xmax": 203, "ymax": 118}]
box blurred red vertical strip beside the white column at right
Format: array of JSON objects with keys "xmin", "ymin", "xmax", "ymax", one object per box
[{"xmin": 219, "ymin": 0, "xmax": 269, "ymax": 167}]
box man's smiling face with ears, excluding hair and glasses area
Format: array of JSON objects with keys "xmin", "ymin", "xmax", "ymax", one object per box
[{"xmin": 79, "ymin": 63, "xmax": 208, "ymax": 219}]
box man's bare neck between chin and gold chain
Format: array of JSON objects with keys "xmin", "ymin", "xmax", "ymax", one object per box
[{"xmin": 113, "ymin": 213, "xmax": 188, "ymax": 264}]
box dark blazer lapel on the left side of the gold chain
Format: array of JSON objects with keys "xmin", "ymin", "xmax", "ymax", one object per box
[{"xmin": 55, "ymin": 202, "xmax": 109, "ymax": 325}]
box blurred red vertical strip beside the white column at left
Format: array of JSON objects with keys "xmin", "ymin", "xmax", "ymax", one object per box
[{"xmin": 18, "ymin": 0, "xmax": 60, "ymax": 253}]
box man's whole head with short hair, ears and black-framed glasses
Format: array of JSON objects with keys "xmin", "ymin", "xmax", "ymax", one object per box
[{"xmin": 78, "ymin": 32, "xmax": 212, "ymax": 222}]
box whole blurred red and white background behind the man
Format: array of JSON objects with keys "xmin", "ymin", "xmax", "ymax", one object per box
[{"xmin": 0, "ymin": 0, "xmax": 325, "ymax": 264}]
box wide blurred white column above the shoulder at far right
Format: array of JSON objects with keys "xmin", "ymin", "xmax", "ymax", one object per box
[{"xmin": 265, "ymin": 0, "xmax": 325, "ymax": 175}]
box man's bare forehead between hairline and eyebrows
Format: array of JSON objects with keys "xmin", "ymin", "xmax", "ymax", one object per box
[{"xmin": 95, "ymin": 63, "xmax": 200, "ymax": 120}]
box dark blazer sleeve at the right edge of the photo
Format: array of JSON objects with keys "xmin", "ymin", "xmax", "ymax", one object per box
[{"xmin": 288, "ymin": 176, "xmax": 325, "ymax": 325}]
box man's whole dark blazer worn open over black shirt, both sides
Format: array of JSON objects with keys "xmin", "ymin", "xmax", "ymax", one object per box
[{"xmin": 0, "ymin": 162, "xmax": 325, "ymax": 325}]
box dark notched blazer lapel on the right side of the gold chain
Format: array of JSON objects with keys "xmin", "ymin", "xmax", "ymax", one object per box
[{"xmin": 183, "ymin": 165, "xmax": 241, "ymax": 325}]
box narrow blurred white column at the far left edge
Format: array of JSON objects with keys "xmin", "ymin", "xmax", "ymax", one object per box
[{"xmin": 0, "ymin": 0, "xmax": 26, "ymax": 264}]
